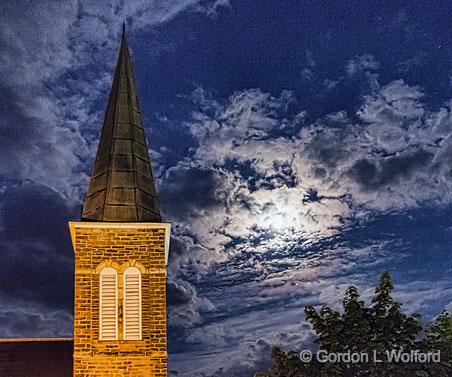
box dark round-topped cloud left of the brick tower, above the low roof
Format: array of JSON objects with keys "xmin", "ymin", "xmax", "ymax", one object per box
[{"xmin": 0, "ymin": 182, "xmax": 77, "ymax": 337}]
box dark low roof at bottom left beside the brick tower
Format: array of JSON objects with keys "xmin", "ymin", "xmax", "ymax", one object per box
[{"xmin": 0, "ymin": 339, "xmax": 74, "ymax": 377}]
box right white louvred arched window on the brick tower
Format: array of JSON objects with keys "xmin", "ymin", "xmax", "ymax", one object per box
[{"xmin": 124, "ymin": 267, "xmax": 141, "ymax": 340}]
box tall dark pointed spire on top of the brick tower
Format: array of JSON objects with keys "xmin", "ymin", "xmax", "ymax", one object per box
[{"xmin": 82, "ymin": 24, "xmax": 161, "ymax": 222}]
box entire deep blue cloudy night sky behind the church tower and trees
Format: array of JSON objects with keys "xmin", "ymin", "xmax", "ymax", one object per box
[{"xmin": 0, "ymin": 0, "xmax": 452, "ymax": 377}]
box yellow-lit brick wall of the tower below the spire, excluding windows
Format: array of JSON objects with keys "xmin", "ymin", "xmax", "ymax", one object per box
[{"xmin": 71, "ymin": 223, "xmax": 168, "ymax": 377}]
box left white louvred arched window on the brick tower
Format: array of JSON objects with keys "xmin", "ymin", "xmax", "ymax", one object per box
[{"xmin": 99, "ymin": 267, "xmax": 118, "ymax": 340}]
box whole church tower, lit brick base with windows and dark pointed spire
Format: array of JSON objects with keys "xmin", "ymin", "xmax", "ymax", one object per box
[{"xmin": 69, "ymin": 25, "xmax": 170, "ymax": 377}]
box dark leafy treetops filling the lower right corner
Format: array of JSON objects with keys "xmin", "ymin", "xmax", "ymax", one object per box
[{"xmin": 256, "ymin": 272, "xmax": 452, "ymax": 377}]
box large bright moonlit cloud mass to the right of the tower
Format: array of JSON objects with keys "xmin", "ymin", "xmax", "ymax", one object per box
[{"xmin": 161, "ymin": 80, "xmax": 452, "ymax": 344}]
